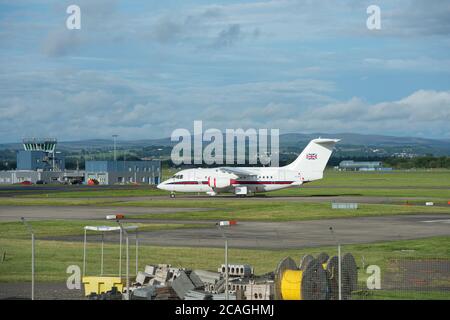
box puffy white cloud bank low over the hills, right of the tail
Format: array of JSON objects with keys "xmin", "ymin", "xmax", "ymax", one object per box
[{"xmin": 298, "ymin": 90, "xmax": 450, "ymax": 138}]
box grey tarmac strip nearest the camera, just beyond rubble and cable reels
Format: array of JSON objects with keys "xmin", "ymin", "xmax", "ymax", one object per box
[{"xmin": 50, "ymin": 214, "xmax": 450, "ymax": 249}]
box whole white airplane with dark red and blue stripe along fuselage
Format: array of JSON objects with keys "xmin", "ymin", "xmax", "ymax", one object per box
[{"xmin": 158, "ymin": 138, "xmax": 340, "ymax": 197}]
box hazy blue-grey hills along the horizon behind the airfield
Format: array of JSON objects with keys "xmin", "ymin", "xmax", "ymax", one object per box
[{"xmin": 0, "ymin": 133, "xmax": 450, "ymax": 156}]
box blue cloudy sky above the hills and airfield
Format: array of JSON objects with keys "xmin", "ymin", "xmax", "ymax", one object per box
[{"xmin": 0, "ymin": 0, "xmax": 450, "ymax": 142}]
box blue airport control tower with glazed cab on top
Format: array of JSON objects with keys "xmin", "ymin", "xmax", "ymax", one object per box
[{"xmin": 17, "ymin": 138, "xmax": 65, "ymax": 171}]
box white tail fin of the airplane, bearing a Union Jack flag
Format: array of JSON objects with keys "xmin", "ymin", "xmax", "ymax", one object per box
[{"xmin": 284, "ymin": 138, "xmax": 340, "ymax": 181}]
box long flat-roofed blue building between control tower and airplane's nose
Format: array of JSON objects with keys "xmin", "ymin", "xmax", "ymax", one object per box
[{"xmin": 84, "ymin": 160, "xmax": 161, "ymax": 184}]
